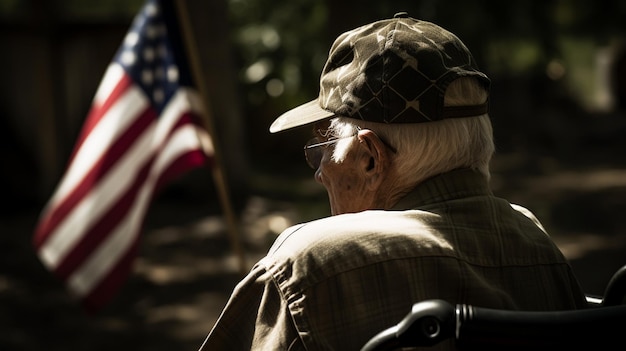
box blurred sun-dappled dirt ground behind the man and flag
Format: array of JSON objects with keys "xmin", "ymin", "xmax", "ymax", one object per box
[{"xmin": 0, "ymin": 133, "xmax": 626, "ymax": 351}]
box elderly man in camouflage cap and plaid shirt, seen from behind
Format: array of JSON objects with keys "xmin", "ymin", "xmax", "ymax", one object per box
[{"xmin": 196, "ymin": 14, "xmax": 585, "ymax": 350}]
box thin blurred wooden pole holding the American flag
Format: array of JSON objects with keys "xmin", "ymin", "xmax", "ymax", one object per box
[{"xmin": 171, "ymin": 0, "xmax": 247, "ymax": 274}]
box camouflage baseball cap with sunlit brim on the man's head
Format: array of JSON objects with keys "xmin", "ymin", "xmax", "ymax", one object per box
[{"xmin": 270, "ymin": 13, "xmax": 490, "ymax": 133}]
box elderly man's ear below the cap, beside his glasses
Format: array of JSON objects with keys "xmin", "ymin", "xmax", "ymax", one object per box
[{"xmin": 357, "ymin": 129, "xmax": 391, "ymax": 189}]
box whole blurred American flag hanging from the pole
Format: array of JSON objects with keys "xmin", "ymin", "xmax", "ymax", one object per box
[{"xmin": 33, "ymin": 0, "xmax": 213, "ymax": 312}]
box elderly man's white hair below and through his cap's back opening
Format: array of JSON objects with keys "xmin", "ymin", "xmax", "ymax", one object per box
[{"xmin": 328, "ymin": 78, "xmax": 495, "ymax": 187}]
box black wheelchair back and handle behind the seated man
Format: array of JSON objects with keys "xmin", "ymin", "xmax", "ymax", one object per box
[{"xmin": 361, "ymin": 265, "xmax": 626, "ymax": 351}]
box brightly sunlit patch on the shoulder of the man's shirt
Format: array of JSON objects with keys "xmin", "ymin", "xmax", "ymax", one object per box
[{"xmin": 265, "ymin": 210, "xmax": 452, "ymax": 276}]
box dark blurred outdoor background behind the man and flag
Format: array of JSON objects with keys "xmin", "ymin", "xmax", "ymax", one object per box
[{"xmin": 0, "ymin": 0, "xmax": 626, "ymax": 350}]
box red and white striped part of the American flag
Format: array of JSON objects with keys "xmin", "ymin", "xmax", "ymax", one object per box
[{"xmin": 34, "ymin": 63, "xmax": 213, "ymax": 309}]
